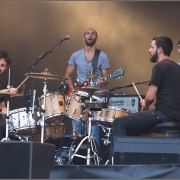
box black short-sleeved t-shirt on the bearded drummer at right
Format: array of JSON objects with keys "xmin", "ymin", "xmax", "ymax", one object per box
[{"xmin": 150, "ymin": 60, "xmax": 180, "ymax": 121}]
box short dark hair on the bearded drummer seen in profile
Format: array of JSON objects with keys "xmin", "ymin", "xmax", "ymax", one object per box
[{"xmin": 153, "ymin": 36, "xmax": 173, "ymax": 56}]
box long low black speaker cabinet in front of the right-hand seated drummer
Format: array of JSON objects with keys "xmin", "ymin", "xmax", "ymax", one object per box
[{"xmin": 113, "ymin": 137, "xmax": 180, "ymax": 165}]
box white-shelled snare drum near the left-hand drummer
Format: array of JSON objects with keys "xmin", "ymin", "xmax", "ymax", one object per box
[{"xmin": 9, "ymin": 108, "xmax": 36, "ymax": 135}]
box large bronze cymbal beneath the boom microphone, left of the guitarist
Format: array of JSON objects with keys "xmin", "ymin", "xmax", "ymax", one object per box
[{"xmin": 25, "ymin": 69, "xmax": 63, "ymax": 80}]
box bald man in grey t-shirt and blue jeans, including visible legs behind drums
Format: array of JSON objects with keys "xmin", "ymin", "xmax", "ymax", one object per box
[{"xmin": 65, "ymin": 28, "xmax": 110, "ymax": 156}]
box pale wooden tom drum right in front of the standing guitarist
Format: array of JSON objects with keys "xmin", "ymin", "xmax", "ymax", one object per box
[{"xmin": 65, "ymin": 91, "xmax": 89, "ymax": 121}]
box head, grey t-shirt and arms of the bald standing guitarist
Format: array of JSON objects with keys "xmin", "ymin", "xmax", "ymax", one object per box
[{"xmin": 65, "ymin": 28, "xmax": 110, "ymax": 90}]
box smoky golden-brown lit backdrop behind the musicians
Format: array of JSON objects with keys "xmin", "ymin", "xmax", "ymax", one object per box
[{"xmin": 0, "ymin": 1, "xmax": 180, "ymax": 109}]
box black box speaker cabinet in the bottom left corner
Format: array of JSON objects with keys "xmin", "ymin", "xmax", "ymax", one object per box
[{"xmin": 0, "ymin": 141, "xmax": 55, "ymax": 179}]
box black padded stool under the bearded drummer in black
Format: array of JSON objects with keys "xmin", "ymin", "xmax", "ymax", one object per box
[{"xmin": 152, "ymin": 121, "xmax": 180, "ymax": 138}]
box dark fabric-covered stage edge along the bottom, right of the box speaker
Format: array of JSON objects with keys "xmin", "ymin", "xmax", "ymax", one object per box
[{"xmin": 49, "ymin": 164, "xmax": 180, "ymax": 180}]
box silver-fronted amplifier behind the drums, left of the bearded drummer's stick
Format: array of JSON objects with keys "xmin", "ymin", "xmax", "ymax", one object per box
[{"xmin": 103, "ymin": 94, "xmax": 141, "ymax": 113}]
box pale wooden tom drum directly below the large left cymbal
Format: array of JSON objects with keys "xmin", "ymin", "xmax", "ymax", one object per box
[{"xmin": 39, "ymin": 92, "xmax": 64, "ymax": 124}]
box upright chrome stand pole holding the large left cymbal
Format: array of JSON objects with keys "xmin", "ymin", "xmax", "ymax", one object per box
[{"xmin": 41, "ymin": 78, "xmax": 47, "ymax": 143}]
